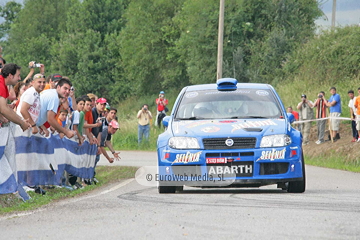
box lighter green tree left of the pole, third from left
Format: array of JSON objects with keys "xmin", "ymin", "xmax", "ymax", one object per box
[{"xmin": 121, "ymin": 0, "xmax": 188, "ymax": 93}]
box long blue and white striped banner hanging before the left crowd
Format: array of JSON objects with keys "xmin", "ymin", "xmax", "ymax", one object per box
[{"xmin": 15, "ymin": 126, "xmax": 97, "ymax": 186}]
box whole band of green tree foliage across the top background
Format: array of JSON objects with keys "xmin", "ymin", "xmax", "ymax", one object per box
[{"xmin": 0, "ymin": 0, "xmax": 321, "ymax": 102}]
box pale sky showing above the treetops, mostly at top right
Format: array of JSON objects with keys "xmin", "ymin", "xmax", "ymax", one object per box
[{"xmin": 0, "ymin": 0, "xmax": 360, "ymax": 29}]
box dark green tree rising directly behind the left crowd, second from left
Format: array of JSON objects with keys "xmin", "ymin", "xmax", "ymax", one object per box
[{"xmin": 52, "ymin": 0, "xmax": 130, "ymax": 100}]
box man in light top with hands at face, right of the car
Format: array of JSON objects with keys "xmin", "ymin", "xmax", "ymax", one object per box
[{"xmin": 297, "ymin": 94, "xmax": 314, "ymax": 145}]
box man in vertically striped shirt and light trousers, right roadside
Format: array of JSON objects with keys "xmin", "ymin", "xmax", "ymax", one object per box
[{"xmin": 314, "ymin": 91, "xmax": 327, "ymax": 144}]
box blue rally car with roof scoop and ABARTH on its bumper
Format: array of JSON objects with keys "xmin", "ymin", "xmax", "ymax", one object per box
[{"xmin": 157, "ymin": 78, "xmax": 305, "ymax": 193}]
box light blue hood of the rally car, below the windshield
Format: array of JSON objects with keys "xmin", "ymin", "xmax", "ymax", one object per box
[{"xmin": 171, "ymin": 119, "xmax": 286, "ymax": 137}]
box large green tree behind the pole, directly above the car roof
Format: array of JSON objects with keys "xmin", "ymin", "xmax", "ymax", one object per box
[{"xmin": 175, "ymin": 0, "xmax": 321, "ymax": 83}]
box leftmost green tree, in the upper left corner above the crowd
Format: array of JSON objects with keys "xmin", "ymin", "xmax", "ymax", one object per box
[{"xmin": 4, "ymin": 0, "xmax": 77, "ymax": 74}]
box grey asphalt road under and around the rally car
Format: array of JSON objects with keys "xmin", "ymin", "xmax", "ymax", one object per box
[{"xmin": 0, "ymin": 152, "xmax": 360, "ymax": 239}]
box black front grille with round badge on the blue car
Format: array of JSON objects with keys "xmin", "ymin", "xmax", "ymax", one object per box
[{"xmin": 203, "ymin": 137, "xmax": 256, "ymax": 149}]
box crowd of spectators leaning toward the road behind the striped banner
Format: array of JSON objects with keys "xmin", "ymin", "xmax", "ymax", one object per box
[{"xmin": 0, "ymin": 61, "xmax": 120, "ymax": 199}]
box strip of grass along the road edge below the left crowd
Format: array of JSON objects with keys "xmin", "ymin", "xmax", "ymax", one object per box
[{"xmin": 0, "ymin": 166, "xmax": 137, "ymax": 215}]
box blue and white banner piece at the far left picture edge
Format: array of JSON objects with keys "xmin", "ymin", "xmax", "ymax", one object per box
[{"xmin": 0, "ymin": 127, "xmax": 18, "ymax": 194}]
